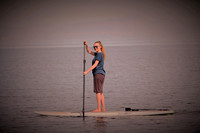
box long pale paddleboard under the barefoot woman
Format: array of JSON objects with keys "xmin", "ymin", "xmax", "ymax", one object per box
[{"xmin": 35, "ymin": 110, "xmax": 174, "ymax": 117}]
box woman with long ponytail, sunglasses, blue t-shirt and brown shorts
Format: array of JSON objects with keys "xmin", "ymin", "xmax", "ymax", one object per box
[{"xmin": 83, "ymin": 41, "xmax": 106, "ymax": 112}]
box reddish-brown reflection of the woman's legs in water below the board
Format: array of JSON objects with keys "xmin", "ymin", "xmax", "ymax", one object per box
[{"xmin": 95, "ymin": 117, "xmax": 106, "ymax": 133}]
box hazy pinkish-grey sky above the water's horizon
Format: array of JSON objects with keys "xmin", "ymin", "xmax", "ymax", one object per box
[{"xmin": 0, "ymin": 0, "xmax": 200, "ymax": 47}]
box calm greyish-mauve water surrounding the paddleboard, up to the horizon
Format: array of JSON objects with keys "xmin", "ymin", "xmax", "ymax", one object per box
[{"xmin": 0, "ymin": 45, "xmax": 200, "ymax": 133}]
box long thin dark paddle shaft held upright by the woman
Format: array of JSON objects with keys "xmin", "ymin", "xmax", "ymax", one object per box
[{"xmin": 83, "ymin": 44, "xmax": 86, "ymax": 117}]
